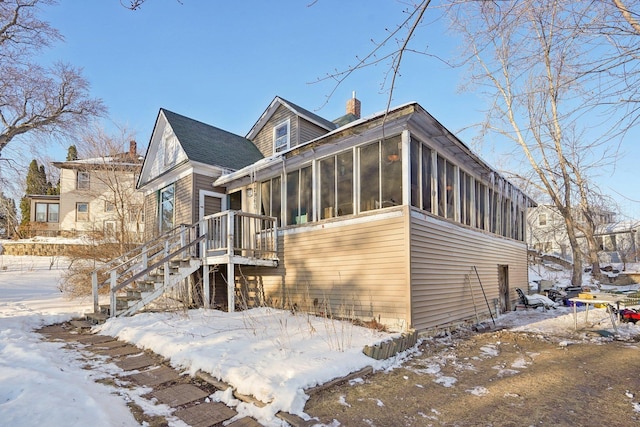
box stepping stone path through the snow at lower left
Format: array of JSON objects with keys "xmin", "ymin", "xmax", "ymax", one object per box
[{"xmin": 36, "ymin": 322, "xmax": 260, "ymax": 427}]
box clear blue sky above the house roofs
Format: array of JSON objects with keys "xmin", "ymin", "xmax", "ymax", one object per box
[{"xmin": 10, "ymin": 0, "xmax": 640, "ymax": 219}]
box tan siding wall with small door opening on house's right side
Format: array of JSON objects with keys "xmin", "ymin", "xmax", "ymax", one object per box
[{"xmin": 411, "ymin": 214, "xmax": 528, "ymax": 329}]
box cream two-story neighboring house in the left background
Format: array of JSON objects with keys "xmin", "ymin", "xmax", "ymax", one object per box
[{"xmin": 52, "ymin": 141, "xmax": 144, "ymax": 241}]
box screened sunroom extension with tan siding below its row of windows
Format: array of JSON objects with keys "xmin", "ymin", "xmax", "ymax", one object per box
[{"xmin": 214, "ymin": 103, "xmax": 532, "ymax": 329}]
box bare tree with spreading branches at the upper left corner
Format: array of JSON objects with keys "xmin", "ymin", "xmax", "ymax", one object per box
[{"xmin": 0, "ymin": 0, "xmax": 106, "ymax": 157}]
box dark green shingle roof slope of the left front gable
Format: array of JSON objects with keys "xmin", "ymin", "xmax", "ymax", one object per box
[{"xmin": 161, "ymin": 108, "xmax": 263, "ymax": 169}]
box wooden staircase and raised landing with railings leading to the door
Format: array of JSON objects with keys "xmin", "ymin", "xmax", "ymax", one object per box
[{"xmin": 89, "ymin": 210, "xmax": 278, "ymax": 321}]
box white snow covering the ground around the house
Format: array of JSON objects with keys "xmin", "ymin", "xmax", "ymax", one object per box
[{"xmin": 0, "ymin": 255, "xmax": 640, "ymax": 427}]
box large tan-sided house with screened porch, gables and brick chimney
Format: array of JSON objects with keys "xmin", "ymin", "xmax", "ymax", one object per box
[{"xmin": 126, "ymin": 94, "xmax": 535, "ymax": 330}]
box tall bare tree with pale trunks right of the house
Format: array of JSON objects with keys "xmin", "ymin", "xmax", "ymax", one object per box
[{"xmin": 442, "ymin": 0, "xmax": 628, "ymax": 285}]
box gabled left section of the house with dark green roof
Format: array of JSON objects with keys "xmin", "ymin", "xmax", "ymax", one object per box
[{"xmin": 138, "ymin": 108, "xmax": 263, "ymax": 238}]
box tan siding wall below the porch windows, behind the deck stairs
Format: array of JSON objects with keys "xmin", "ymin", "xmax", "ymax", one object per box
[{"xmin": 242, "ymin": 215, "xmax": 409, "ymax": 326}]
